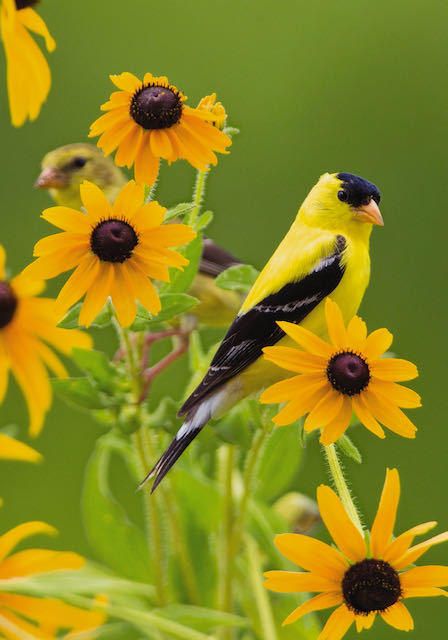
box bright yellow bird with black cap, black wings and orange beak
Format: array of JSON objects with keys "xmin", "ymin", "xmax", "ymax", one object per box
[{"xmin": 142, "ymin": 173, "xmax": 383, "ymax": 491}]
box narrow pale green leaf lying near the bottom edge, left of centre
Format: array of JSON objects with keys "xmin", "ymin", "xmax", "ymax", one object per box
[{"xmin": 154, "ymin": 604, "xmax": 247, "ymax": 632}]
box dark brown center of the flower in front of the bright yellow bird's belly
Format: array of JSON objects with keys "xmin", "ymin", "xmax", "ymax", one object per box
[{"xmin": 327, "ymin": 351, "xmax": 370, "ymax": 396}]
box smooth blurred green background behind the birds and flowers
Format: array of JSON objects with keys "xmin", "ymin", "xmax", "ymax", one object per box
[{"xmin": 0, "ymin": 0, "xmax": 448, "ymax": 640}]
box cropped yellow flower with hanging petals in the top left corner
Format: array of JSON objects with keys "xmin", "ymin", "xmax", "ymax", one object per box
[{"xmin": 0, "ymin": 0, "xmax": 56, "ymax": 127}]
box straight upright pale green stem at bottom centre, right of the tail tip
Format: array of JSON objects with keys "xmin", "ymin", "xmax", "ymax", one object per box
[{"xmin": 218, "ymin": 445, "xmax": 235, "ymax": 640}]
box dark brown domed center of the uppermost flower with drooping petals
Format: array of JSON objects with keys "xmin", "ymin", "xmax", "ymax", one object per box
[{"xmin": 130, "ymin": 85, "xmax": 182, "ymax": 129}]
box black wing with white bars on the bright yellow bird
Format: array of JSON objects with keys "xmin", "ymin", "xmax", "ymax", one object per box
[{"xmin": 179, "ymin": 236, "xmax": 346, "ymax": 415}]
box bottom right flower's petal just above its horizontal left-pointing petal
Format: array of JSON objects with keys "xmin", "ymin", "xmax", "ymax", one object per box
[{"xmin": 274, "ymin": 533, "xmax": 348, "ymax": 582}]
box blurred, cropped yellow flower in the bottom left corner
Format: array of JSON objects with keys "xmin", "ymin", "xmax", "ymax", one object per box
[{"xmin": 0, "ymin": 522, "xmax": 105, "ymax": 640}]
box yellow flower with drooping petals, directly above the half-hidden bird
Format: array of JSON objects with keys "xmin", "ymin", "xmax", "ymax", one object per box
[{"xmin": 89, "ymin": 73, "xmax": 232, "ymax": 185}]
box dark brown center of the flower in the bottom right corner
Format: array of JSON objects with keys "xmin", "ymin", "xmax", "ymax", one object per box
[{"xmin": 342, "ymin": 559, "xmax": 402, "ymax": 615}]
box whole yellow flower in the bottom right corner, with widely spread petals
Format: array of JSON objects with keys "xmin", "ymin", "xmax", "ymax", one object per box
[{"xmin": 265, "ymin": 469, "xmax": 448, "ymax": 640}]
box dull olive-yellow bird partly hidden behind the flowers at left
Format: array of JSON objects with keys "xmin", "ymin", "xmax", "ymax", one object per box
[{"xmin": 35, "ymin": 142, "xmax": 242, "ymax": 328}]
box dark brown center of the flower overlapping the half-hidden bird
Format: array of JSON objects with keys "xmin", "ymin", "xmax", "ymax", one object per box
[{"xmin": 90, "ymin": 219, "xmax": 138, "ymax": 262}]
